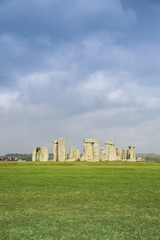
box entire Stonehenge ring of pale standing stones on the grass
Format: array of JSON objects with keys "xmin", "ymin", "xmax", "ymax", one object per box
[{"xmin": 32, "ymin": 138, "xmax": 136, "ymax": 162}]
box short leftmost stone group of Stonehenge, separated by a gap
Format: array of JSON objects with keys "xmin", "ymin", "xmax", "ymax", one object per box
[{"xmin": 32, "ymin": 147, "xmax": 48, "ymax": 162}]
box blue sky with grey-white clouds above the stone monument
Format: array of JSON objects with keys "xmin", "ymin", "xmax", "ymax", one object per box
[{"xmin": 0, "ymin": 0, "xmax": 160, "ymax": 154}]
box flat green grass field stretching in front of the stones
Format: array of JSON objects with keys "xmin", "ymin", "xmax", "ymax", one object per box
[{"xmin": 0, "ymin": 162, "xmax": 160, "ymax": 240}]
